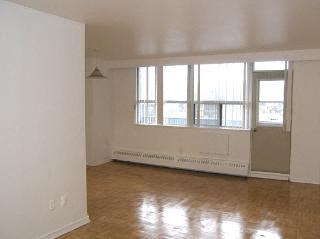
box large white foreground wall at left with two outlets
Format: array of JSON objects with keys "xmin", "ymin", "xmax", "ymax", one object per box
[{"xmin": 0, "ymin": 0, "xmax": 88, "ymax": 239}]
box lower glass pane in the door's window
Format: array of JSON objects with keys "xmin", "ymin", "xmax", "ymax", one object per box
[{"xmin": 259, "ymin": 103, "xmax": 283, "ymax": 124}]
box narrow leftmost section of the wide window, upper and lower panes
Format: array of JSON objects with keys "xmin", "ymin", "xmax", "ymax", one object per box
[{"xmin": 136, "ymin": 66, "xmax": 157, "ymax": 124}]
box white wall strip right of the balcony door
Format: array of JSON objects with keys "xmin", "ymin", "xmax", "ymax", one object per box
[{"xmin": 290, "ymin": 61, "xmax": 320, "ymax": 184}]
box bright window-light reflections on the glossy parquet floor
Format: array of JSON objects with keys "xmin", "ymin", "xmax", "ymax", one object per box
[{"xmin": 138, "ymin": 195, "xmax": 282, "ymax": 239}]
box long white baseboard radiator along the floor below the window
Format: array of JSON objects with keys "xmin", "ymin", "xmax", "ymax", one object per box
[{"xmin": 112, "ymin": 149, "xmax": 249, "ymax": 176}]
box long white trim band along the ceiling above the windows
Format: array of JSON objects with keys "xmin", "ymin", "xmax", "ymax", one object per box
[{"xmin": 104, "ymin": 49, "xmax": 320, "ymax": 69}]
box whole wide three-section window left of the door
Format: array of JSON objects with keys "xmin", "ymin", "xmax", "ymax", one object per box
[{"xmin": 136, "ymin": 63, "xmax": 246, "ymax": 128}]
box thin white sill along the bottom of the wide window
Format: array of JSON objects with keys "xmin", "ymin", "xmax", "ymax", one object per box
[{"xmin": 134, "ymin": 123, "xmax": 251, "ymax": 132}]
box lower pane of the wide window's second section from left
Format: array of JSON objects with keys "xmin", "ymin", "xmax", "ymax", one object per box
[{"xmin": 163, "ymin": 103, "xmax": 187, "ymax": 125}]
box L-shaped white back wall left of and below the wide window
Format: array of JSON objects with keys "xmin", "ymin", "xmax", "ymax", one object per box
[{"xmin": 113, "ymin": 68, "xmax": 250, "ymax": 162}]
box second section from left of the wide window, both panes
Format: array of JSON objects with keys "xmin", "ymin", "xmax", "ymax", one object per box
[{"xmin": 163, "ymin": 65, "xmax": 188, "ymax": 126}]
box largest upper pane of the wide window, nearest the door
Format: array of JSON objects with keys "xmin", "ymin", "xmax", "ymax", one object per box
[{"xmin": 200, "ymin": 63, "xmax": 244, "ymax": 101}]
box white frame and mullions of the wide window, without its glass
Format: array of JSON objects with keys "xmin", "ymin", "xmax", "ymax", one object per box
[{"xmin": 134, "ymin": 62, "xmax": 254, "ymax": 131}]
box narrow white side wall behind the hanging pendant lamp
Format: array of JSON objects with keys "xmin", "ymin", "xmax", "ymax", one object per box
[{"xmin": 86, "ymin": 57, "xmax": 113, "ymax": 165}]
